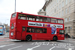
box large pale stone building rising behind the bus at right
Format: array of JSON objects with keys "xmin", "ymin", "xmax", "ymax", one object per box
[{"xmin": 38, "ymin": 0, "xmax": 75, "ymax": 37}]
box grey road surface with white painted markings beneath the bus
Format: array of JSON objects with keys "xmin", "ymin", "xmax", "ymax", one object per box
[{"xmin": 0, "ymin": 32, "xmax": 75, "ymax": 50}]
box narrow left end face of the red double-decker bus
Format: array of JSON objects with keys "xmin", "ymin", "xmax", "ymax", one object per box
[{"xmin": 9, "ymin": 13, "xmax": 17, "ymax": 39}]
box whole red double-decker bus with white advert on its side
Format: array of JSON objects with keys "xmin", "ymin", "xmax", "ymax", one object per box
[{"xmin": 9, "ymin": 12, "xmax": 64, "ymax": 41}]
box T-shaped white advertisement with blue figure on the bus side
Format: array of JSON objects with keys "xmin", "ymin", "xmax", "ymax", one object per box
[{"xmin": 28, "ymin": 22, "xmax": 63, "ymax": 34}]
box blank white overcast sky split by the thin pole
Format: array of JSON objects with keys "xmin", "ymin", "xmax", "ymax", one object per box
[{"xmin": 0, "ymin": 0, "xmax": 45, "ymax": 25}]
